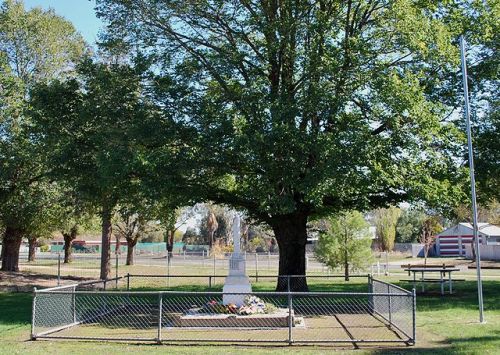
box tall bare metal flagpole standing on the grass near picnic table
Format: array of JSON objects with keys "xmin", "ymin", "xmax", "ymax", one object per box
[{"xmin": 460, "ymin": 36, "xmax": 484, "ymax": 323}]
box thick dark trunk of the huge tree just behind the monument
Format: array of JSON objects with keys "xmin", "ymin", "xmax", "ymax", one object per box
[{"xmin": 271, "ymin": 213, "xmax": 308, "ymax": 292}]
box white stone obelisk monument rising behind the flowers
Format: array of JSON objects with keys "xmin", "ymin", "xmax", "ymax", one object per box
[{"xmin": 222, "ymin": 214, "xmax": 252, "ymax": 307}]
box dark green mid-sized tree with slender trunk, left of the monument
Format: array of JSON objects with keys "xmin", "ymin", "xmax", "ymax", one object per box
[{"xmin": 31, "ymin": 59, "xmax": 159, "ymax": 279}]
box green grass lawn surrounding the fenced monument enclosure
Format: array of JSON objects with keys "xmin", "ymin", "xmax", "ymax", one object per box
[{"xmin": 0, "ymin": 278, "xmax": 500, "ymax": 354}]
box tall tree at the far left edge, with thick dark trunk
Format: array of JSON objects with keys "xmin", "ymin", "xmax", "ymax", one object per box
[{"xmin": 0, "ymin": 0, "xmax": 85, "ymax": 271}]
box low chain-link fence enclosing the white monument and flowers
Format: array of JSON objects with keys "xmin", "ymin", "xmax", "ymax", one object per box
[{"xmin": 31, "ymin": 278, "xmax": 415, "ymax": 344}]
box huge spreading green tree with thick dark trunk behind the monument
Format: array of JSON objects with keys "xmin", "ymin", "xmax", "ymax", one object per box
[{"xmin": 97, "ymin": 0, "xmax": 490, "ymax": 289}]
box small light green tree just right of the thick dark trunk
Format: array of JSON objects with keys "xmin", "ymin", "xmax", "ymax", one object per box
[{"xmin": 314, "ymin": 211, "xmax": 373, "ymax": 281}]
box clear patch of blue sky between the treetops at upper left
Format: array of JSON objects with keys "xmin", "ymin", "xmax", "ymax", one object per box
[{"xmin": 24, "ymin": 0, "xmax": 103, "ymax": 45}]
